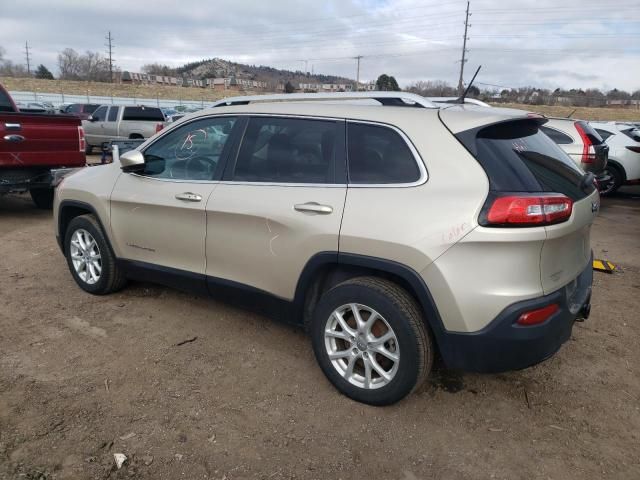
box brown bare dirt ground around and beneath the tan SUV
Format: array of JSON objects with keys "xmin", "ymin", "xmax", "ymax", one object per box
[{"xmin": 0, "ymin": 189, "xmax": 640, "ymax": 480}]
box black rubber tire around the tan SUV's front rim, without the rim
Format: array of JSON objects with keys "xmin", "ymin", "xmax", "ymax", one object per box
[{"xmin": 64, "ymin": 215, "xmax": 127, "ymax": 295}]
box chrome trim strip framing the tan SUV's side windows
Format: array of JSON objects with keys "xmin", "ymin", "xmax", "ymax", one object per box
[{"xmin": 138, "ymin": 112, "xmax": 429, "ymax": 188}]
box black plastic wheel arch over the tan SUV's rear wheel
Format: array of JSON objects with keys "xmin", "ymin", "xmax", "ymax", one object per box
[{"xmin": 293, "ymin": 252, "xmax": 445, "ymax": 343}]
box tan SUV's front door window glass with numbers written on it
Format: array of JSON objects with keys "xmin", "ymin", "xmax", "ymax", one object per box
[{"xmin": 143, "ymin": 117, "xmax": 236, "ymax": 180}]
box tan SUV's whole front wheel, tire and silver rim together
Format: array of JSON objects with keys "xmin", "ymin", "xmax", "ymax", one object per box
[{"xmin": 64, "ymin": 215, "xmax": 126, "ymax": 295}]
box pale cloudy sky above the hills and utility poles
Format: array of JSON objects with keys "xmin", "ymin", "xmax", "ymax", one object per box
[{"xmin": 0, "ymin": 0, "xmax": 640, "ymax": 91}]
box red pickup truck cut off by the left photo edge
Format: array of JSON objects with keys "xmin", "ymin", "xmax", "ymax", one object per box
[{"xmin": 0, "ymin": 85, "xmax": 86, "ymax": 208}]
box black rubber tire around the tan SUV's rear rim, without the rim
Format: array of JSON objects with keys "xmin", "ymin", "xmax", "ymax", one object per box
[{"xmin": 310, "ymin": 277, "xmax": 434, "ymax": 405}]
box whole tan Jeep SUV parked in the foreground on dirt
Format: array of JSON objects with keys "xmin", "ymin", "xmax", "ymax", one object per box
[{"xmin": 54, "ymin": 92, "xmax": 599, "ymax": 405}]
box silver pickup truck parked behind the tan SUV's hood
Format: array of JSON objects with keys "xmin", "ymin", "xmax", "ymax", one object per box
[{"xmin": 82, "ymin": 105, "xmax": 165, "ymax": 154}]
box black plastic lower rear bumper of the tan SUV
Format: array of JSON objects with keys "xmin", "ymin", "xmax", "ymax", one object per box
[{"xmin": 439, "ymin": 256, "xmax": 593, "ymax": 373}]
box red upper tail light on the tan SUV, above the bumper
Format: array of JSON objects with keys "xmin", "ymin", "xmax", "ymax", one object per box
[{"xmin": 480, "ymin": 193, "xmax": 573, "ymax": 227}]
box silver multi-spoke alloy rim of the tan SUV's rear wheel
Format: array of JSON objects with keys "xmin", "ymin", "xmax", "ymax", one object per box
[{"xmin": 324, "ymin": 303, "xmax": 400, "ymax": 389}]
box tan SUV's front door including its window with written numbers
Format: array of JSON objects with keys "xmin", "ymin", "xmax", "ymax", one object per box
[{"xmin": 111, "ymin": 117, "xmax": 236, "ymax": 275}]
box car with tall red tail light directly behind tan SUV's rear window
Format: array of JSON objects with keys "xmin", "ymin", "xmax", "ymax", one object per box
[{"xmin": 540, "ymin": 117, "xmax": 610, "ymax": 188}]
